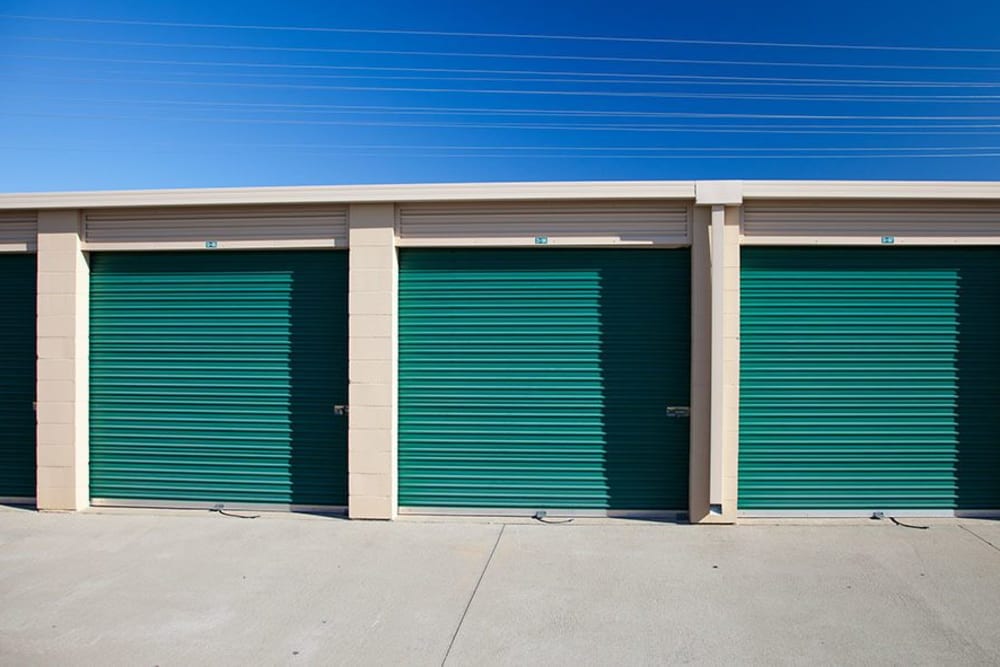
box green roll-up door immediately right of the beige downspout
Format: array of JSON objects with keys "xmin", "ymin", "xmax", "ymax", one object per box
[{"xmin": 739, "ymin": 247, "xmax": 1000, "ymax": 510}]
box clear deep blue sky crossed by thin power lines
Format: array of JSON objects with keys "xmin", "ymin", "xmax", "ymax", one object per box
[{"xmin": 0, "ymin": 0, "xmax": 1000, "ymax": 192}]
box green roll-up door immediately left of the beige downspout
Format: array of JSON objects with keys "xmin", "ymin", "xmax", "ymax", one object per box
[{"xmin": 399, "ymin": 248, "xmax": 690, "ymax": 510}]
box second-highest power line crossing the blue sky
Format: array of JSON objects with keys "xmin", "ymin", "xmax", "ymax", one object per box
[{"xmin": 15, "ymin": 35, "xmax": 1000, "ymax": 72}]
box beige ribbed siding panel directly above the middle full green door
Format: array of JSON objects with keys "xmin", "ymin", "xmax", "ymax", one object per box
[{"xmin": 399, "ymin": 201, "xmax": 691, "ymax": 246}]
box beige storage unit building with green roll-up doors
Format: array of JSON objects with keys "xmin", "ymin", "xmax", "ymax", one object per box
[{"xmin": 0, "ymin": 181, "xmax": 1000, "ymax": 523}]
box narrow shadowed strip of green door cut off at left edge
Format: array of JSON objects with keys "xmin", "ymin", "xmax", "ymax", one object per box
[{"xmin": 0, "ymin": 254, "xmax": 37, "ymax": 498}]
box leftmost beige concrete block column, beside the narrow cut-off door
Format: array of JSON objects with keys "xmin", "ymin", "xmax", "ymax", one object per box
[{"xmin": 36, "ymin": 210, "xmax": 90, "ymax": 510}]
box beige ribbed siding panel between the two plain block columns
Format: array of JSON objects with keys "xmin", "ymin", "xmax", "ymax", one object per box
[{"xmin": 83, "ymin": 205, "xmax": 347, "ymax": 250}]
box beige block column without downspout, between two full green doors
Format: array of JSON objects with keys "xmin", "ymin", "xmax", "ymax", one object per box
[{"xmin": 348, "ymin": 204, "xmax": 399, "ymax": 519}]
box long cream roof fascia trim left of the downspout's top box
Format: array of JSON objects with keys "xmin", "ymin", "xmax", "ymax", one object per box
[{"xmin": 0, "ymin": 181, "xmax": 695, "ymax": 209}]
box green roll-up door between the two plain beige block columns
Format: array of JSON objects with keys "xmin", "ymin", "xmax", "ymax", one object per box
[{"xmin": 90, "ymin": 251, "xmax": 347, "ymax": 505}]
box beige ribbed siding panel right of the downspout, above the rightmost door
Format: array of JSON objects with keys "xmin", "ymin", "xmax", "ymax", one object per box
[{"xmin": 742, "ymin": 201, "xmax": 1000, "ymax": 245}]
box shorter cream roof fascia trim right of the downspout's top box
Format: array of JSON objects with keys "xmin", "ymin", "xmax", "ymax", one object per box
[{"xmin": 743, "ymin": 181, "xmax": 1000, "ymax": 199}]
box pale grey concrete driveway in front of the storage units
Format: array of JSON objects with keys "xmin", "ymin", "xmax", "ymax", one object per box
[{"xmin": 0, "ymin": 509, "xmax": 1000, "ymax": 667}]
